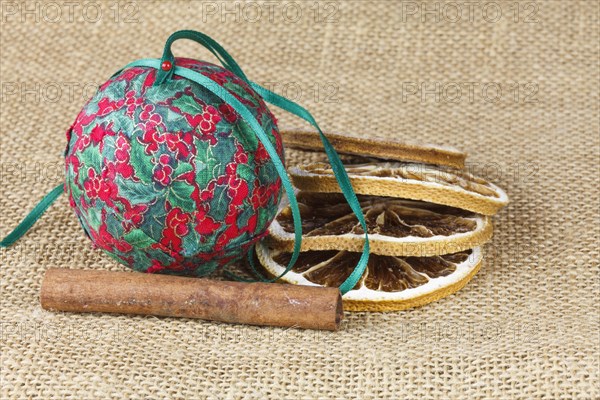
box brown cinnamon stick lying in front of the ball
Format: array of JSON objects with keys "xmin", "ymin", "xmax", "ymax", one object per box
[{"xmin": 40, "ymin": 268, "xmax": 343, "ymax": 330}]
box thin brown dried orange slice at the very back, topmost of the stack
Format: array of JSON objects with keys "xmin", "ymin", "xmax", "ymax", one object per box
[{"xmin": 281, "ymin": 130, "xmax": 467, "ymax": 168}]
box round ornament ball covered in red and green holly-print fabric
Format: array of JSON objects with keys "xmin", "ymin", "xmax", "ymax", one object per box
[{"xmin": 65, "ymin": 58, "xmax": 284, "ymax": 276}]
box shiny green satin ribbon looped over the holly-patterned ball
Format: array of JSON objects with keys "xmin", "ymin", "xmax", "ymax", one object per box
[{"xmin": 0, "ymin": 30, "xmax": 369, "ymax": 294}]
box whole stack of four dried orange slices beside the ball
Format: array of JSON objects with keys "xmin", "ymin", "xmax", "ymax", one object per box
[{"xmin": 256, "ymin": 131, "xmax": 508, "ymax": 311}]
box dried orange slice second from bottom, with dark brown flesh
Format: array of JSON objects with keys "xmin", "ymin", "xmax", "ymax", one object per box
[{"xmin": 269, "ymin": 192, "xmax": 493, "ymax": 256}]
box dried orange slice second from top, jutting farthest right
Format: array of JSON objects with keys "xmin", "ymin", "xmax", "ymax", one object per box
[{"xmin": 289, "ymin": 161, "xmax": 508, "ymax": 215}]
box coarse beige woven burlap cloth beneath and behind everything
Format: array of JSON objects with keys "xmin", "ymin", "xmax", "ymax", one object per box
[{"xmin": 0, "ymin": 0, "xmax": 600, "ymax": 399}]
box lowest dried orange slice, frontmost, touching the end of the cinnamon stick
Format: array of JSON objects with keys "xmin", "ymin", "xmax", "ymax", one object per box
[{"xmin": 256, "ymin": 243, "xmax": 483, "ymax": 311}]
